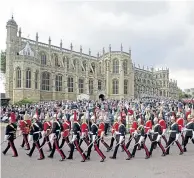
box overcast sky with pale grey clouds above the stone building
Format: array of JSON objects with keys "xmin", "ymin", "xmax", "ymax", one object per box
[{"xmin": 0, "ymin": 0, "xmax": 194, "ymax": 92}]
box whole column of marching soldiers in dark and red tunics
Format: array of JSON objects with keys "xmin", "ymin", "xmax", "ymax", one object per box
[{"xmin": 2, "ymin": 105, "xmax": 194, "ymax": 162}]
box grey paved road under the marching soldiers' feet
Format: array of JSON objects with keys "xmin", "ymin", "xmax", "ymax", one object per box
[{"xmin": 1, "ymin": 127, "xmax": 194, "ymax": 178}]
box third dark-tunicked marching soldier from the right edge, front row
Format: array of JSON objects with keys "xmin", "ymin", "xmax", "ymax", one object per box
[{"xmin": 149, "ymin": 118, "xmax": 165, "ymax": 156}]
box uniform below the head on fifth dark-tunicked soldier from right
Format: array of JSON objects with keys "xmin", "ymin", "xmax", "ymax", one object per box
[{"xmin": 110, "ymin": 124, "xmax": 131, "ymax": 160}]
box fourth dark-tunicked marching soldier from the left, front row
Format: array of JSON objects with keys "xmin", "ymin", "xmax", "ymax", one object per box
[{"xmin": 67, "ymin": 114, "xmax": 86, "ymax": 162}]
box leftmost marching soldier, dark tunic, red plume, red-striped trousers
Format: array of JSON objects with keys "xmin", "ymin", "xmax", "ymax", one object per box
[{"xmin": 2, "ymin": 113, "xmax": 18, "ymax": 157}]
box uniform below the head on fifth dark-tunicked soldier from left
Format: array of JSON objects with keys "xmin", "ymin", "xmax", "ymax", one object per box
[{"xmin": 86, "ymin": 123, "xmax": 106, "ymax": 162}]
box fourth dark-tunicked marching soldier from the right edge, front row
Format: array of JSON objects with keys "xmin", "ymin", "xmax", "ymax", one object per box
[{"xmin": 132, "ymin": 119, "xmax": 150, "ymax": 159}]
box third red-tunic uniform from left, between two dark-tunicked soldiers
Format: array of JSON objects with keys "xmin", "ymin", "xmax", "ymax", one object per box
[{"xmin": 59, "ymin": 121, "xmax": 71, "ymax": 148}]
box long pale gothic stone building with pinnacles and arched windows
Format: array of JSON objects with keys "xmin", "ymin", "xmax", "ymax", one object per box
[{"xmin": 5, "ymin": 17, "xmax": 177, "ymax": 103}]
